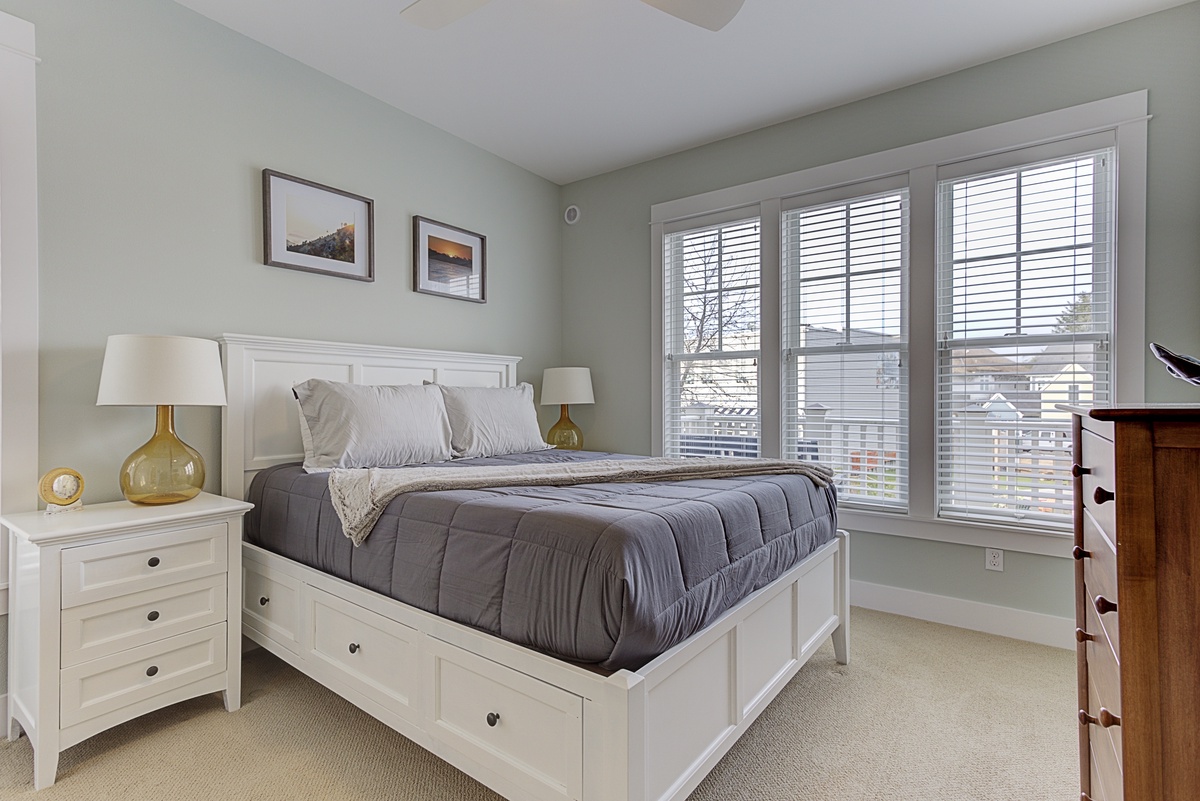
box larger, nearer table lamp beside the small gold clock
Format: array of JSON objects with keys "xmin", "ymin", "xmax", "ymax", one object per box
[{"xmin": 96, "ymin": 333, "xmax": 226, "ymax": 504}]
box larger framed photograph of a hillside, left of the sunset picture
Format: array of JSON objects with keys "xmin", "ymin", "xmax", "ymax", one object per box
[{"xmin": 263, "ymin": 169, "xmax": 374, "ymax": 281}]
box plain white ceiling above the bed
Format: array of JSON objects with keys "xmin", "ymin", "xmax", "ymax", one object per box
[{"xmin": 176, "ymin": 0, "xmax": 1190, "ymax": 183}]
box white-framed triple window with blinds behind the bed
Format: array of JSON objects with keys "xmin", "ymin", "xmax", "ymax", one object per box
[{"xmin": 650, "ymin": 92, "xmax": 1148, "ymax": 555}]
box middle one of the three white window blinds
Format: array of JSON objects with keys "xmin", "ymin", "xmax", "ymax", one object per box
[{"xmin": 782, "ymin": 188, "xmax": 908, "ymax": 510}]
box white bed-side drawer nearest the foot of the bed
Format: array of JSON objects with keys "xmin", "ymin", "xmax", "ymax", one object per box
[{"xmin": 427, "ymin": 638, "xmax": 583, "ymax": 799}]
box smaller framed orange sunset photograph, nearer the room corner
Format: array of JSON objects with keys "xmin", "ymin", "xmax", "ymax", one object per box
[{"xmin": 413, "ymin": 216, "xmax": 487, "ymax": 303}]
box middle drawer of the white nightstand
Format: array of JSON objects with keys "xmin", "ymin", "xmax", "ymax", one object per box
[{"xmin": 61, "ymin": 573, "xmax": 226, "ymax": 668}]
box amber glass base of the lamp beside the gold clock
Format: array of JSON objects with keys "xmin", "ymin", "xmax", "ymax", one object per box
[{"xmin": 121, "ymin": 406, "xmax": 204, "ymax": 504}]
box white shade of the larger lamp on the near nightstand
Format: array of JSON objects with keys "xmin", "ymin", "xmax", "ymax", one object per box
[{"xmin": 96, "ymin": 333, "xmax": 226, "ymax": 406}]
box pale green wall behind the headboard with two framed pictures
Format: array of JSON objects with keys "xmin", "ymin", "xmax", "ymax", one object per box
[{"xmin": 0, "ymin": 0, "xmax": 562, "ymax": 695}]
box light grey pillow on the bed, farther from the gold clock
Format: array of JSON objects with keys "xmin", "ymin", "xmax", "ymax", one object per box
[{"xmin": 437, "ymin": 384, "xmax": 554, "ymax": 459}]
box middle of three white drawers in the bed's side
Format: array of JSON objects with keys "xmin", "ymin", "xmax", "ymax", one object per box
[{"xmin": 304, "ymin": 586, "xmax": 419, "ymax": 715}]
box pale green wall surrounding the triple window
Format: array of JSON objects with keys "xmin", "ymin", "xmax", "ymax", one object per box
[{"xmin": 563, "ymin": 4, "xmax": 1200, "ymax": 616}]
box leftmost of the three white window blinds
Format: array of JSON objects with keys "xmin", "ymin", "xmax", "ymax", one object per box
[{"xmin": 662, "ymin": 217, "xmax": 761, "ymax": 456}]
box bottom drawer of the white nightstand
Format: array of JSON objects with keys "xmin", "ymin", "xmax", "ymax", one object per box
[{"xmin": 59, "ymin": 624, "xmax": 226, "ymax": 728}]
